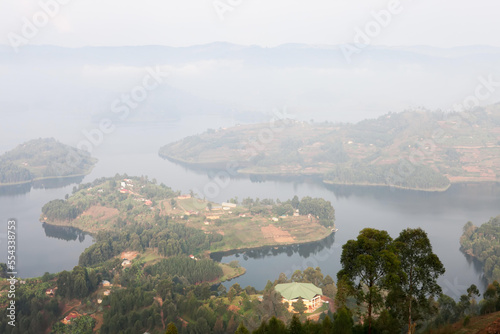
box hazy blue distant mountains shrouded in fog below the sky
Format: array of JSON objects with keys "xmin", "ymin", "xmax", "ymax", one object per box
[{"xmin": 0, "ymin": 43, "xmax": 500, "ymax": 122}]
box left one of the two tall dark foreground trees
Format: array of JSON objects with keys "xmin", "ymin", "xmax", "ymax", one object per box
[{"xmin": 337, "ymin": 228, "xmax": 399, "ymax": 333}]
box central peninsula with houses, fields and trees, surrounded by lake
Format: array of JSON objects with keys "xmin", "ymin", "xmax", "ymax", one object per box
[{"xmin": 41, "ymin": 175, "xmax": 335, "ymax": 253}]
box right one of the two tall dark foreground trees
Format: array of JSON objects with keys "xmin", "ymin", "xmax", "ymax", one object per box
[{"xmin": 394, "ymin": 228, "xmax": 445, "ymax": 333}]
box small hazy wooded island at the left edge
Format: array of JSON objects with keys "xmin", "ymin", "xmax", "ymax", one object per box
[{"xmin": 0, "ymin": 138, "xmax": 97, "ymax": 186}]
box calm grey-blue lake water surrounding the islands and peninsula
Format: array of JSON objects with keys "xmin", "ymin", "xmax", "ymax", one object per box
[{"xmin": 0, "ymin": 116, "xmax": 500, "ymax": 298}]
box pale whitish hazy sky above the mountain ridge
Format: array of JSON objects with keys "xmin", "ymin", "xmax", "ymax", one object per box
[{"xmin": 0, "ymin": 0, "xmax": 500, "ymax": 47}]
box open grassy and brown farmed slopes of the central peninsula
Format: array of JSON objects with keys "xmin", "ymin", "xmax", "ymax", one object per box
[{"xmin": 41, "ymin": 179, "xmax": 331, "ymax": 251}]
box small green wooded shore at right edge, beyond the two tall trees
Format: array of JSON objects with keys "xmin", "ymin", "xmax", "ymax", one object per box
[{"xmin": 460, "ymin": 216, "xmax": 500, "ymax": 283}]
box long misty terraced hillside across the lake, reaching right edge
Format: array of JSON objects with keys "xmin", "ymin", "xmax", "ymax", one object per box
[{"xmin": 159, "ymin": 104, "xmax": 500, "ymax": 191}]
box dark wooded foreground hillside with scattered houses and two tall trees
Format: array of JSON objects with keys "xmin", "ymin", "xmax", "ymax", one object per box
[{"xmin": 0, "ymin": 228, "xmax": 500, "ymax": 334}]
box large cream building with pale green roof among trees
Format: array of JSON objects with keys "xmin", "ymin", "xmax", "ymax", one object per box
[{"xmin": 274, "ymin": 282, "xmax": 323, "ymax": 312}]
